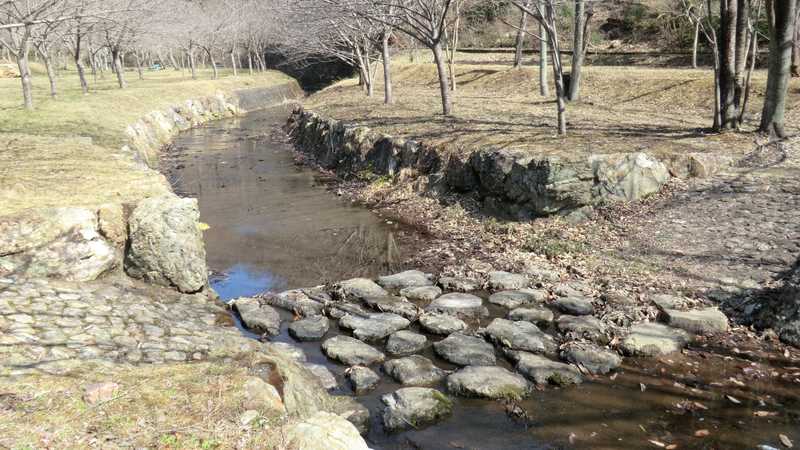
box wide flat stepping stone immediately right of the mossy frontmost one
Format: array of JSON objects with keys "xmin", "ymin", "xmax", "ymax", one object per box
[{"xmin": 447, "ymin": 366, "xmax": 532, "ymax": 400}]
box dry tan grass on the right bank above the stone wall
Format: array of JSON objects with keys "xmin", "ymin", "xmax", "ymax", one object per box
[{"xmin": 307, "ymin": 55, "xmax": 800, "ymax": 161}]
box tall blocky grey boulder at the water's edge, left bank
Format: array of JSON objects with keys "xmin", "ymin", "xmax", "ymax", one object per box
[{"xmin": 125, "ymin": 195, "xmax": 208, "ymax": 292}]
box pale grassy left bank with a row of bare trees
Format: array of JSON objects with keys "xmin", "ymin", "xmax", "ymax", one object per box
[{"xmin": 0, "ymin": 67, "xmax": 296, "ymax": 215}]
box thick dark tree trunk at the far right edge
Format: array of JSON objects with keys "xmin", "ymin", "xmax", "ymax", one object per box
[{"xmin": 760, "ymin": 0, "xmax": 797, "ymax": 138}]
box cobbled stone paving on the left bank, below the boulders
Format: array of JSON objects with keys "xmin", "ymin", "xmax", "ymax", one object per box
[{"xmin": 0, "ymin": 277, "xmax": 258, "ymax": 376}]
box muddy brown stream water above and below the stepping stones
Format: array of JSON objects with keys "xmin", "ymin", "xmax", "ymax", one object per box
[{"xmin": 166, "ymin": 109, "xmax": 800, "ymax": 450}]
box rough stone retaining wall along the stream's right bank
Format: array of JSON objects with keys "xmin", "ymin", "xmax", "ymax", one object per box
[{"xmin": 288, "ymin": 107, "xmax": 672, "ymax": 219}]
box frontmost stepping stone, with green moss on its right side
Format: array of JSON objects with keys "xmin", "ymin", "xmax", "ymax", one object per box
[{"xmin": 381, "ymin": 387, "xmax": 453, "ymax": 431}]
